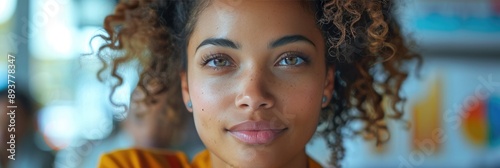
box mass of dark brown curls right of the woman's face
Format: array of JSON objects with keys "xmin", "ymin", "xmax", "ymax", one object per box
[{"xmin": 318, "ymin": 0, "xmax": 421, "ymax": 167}]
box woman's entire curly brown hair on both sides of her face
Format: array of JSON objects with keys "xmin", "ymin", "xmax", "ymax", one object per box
[{"xmin": 97, "ymin": 0, "xmax": 421, "ymax": 167}]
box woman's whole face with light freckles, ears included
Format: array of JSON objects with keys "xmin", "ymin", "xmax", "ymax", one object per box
[{"xmin": 181, "ymin": 1, "xmax": 333, "ymax": 167}]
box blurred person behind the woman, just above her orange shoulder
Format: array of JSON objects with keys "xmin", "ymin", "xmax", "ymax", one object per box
[{"xmin": 122, "ymin": 86, "xmax": 203, "ymax": 157}]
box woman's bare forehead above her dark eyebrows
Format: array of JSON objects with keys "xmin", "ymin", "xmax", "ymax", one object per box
[{"xmin": 189, "ymin": 0, "xmax": 319, "ymax": 48}]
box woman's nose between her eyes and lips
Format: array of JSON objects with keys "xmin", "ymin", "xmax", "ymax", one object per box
[{"xmin": 235, "ymin": 68, "xmax": 275, "ymax": 111}]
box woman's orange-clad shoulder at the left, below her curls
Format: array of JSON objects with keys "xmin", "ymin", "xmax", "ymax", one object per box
[{"xmin": 99, "ymin": 148, "xmax": 189, "ymax": 168}]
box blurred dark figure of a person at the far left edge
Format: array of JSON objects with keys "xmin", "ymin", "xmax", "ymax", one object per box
[{"xmin": 0, "ymin": 89, "xmax": 55, "ymax": 168}]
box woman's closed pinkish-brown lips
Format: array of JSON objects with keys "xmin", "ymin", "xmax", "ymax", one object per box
[{"xmin": 227, "ymin": 121, "xmax": 287, "ymax": 145}]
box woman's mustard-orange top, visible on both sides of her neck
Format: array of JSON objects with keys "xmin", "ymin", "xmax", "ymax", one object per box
[{"xmin": 99, "ymin": 149, "xmax": 321, "ymax": 168}]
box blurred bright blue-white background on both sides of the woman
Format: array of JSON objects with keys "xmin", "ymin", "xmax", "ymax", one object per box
[{"xmin": 0, "ymin": 0, "xmax": 500, "ymax": 168}]
